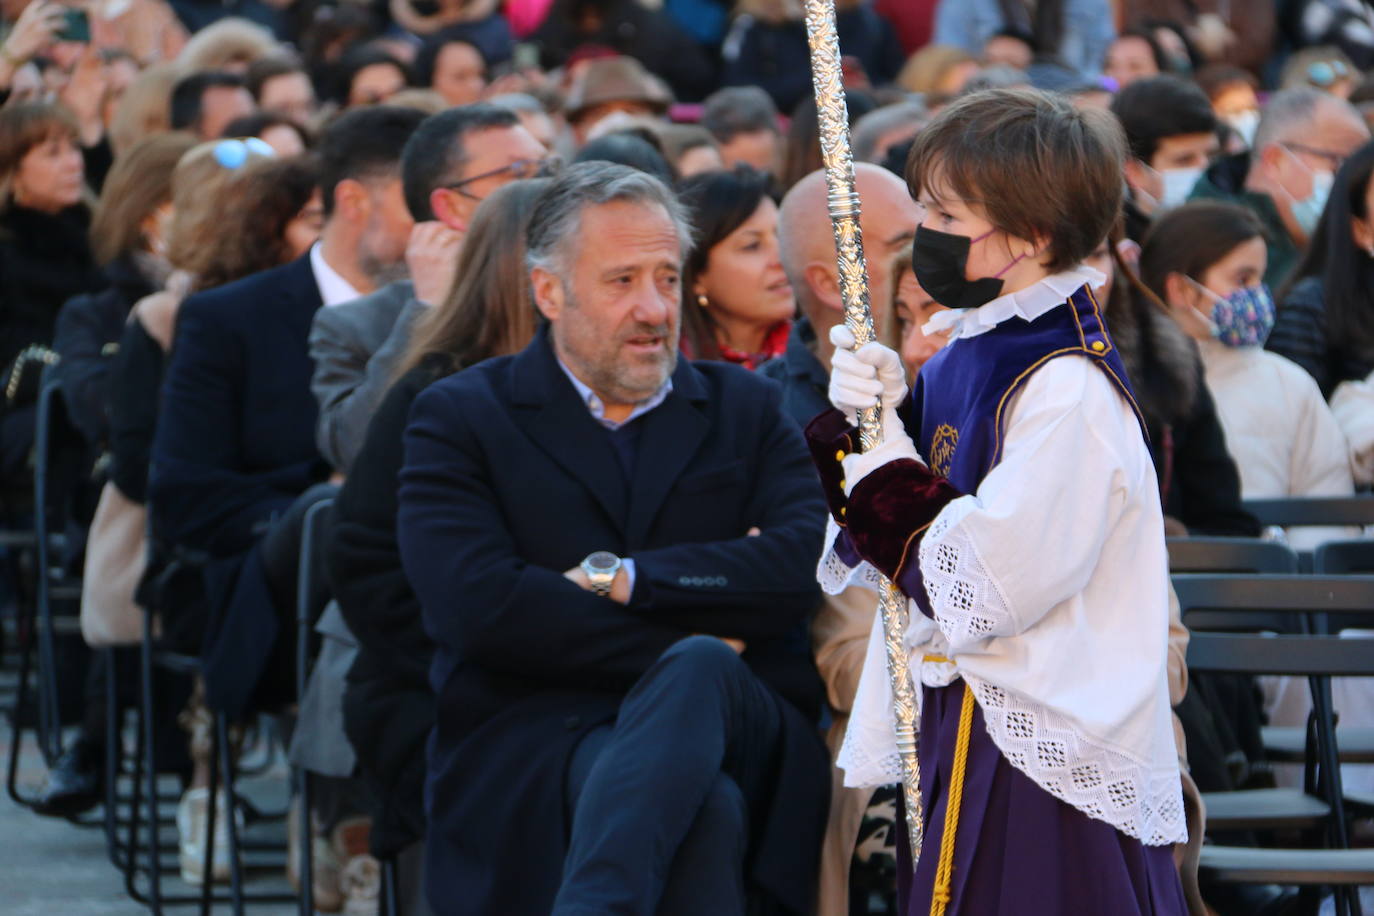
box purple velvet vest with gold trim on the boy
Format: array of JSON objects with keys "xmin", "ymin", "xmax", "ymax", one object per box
[{"xmin": 907, "ymin": 286, "xmax": 1145, "ymax": 493}]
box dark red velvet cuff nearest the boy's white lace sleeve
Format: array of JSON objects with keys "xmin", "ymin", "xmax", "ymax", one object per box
[{"xmin": 848, "ymin": 459, "xmax": 960, "ymax": 581}]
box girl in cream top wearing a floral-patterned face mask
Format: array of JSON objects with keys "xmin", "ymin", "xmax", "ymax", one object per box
[{"xmin": 1140, "ymin": 202, "xmax": 1355, "ymax": 547}]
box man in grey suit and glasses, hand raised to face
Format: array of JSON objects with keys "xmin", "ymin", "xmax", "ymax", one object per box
[{"xmin": 311, "ymin": 104, "xmax": 548, "ymax": 474}]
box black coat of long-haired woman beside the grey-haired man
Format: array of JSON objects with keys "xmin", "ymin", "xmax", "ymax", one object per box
[{"xmin": 326, "ymin": 363, "xmax": 448, "ymax": 857}]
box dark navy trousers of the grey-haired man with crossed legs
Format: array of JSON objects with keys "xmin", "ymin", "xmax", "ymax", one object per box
[{"xmin": 554, "ymin": 636, "xmax": 783, "ymax": 916}]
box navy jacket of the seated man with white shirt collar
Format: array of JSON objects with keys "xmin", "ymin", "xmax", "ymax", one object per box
[{"xmin": 148, "ymin": 255, "xmax": 328, "ymax": 715}]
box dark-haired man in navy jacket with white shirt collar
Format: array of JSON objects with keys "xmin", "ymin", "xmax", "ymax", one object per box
[{"xmin": 148, "ymin": 107, "xmax": 423, "ymax": 715}]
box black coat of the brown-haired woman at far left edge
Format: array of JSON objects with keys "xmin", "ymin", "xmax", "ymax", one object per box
[{"xmin": 0, "ymin": 203, "xmax": 106, "ymax": 367}]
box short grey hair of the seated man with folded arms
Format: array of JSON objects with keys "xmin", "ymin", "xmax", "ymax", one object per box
[{"xmin": 525, "ymin": 162, "xmax": 692, "ymax": 276}]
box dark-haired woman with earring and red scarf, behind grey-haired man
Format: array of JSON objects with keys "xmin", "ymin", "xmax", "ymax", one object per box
[{"xmin": 679, "ymin": 166, "xmax": 797, "ymax": 369}]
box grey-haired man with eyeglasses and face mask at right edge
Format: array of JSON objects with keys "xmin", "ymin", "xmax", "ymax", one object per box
[{"xmin": 1193, "ymin": 88, "xmax": 1370, "ymax": 288}]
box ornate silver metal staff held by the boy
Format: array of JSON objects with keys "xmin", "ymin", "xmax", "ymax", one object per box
[{"xmin": 805, "ymin": 0, "xmax": 923, "ymax": 864}]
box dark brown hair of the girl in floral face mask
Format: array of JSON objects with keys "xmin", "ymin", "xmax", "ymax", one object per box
[{"xmin": 1140, "ymin": 201, "xmax": 1264, "ymax": 301}]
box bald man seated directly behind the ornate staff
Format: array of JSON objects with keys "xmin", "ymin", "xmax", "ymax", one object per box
[{"xmin": 763, "ymin": 162, "xmax": 921, "ymax": 426}]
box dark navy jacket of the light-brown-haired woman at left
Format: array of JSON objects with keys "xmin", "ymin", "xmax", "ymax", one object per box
[{"xmin": 52, "ymin": 258, "xmax": 154, "ymax": 448}]
